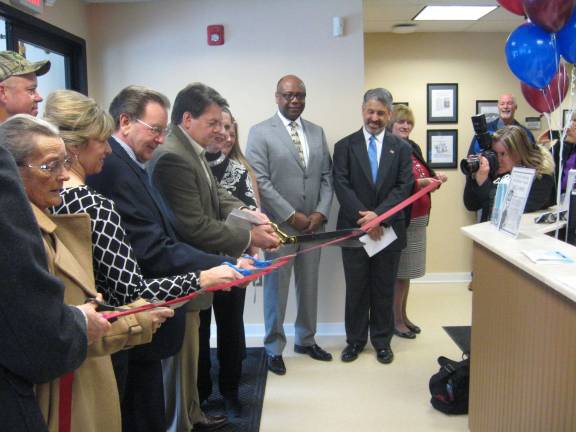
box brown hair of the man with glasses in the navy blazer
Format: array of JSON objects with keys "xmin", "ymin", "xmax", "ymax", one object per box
[{"xmin": 108, "ymin": 85, "xmax": 170, "ymax": 129}]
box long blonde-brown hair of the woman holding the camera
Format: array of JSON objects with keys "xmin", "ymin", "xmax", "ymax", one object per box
[{"xmin": 492, "ymin": 125, "xmax": 554, "ymax": 178}]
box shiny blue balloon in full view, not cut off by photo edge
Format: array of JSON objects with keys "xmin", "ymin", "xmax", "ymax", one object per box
[{"xmin": 506, "ymin": 23, "xmax": 560, "ymax": 88}]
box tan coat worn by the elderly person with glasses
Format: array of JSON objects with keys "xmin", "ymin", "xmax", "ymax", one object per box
[{"xmin": 32, "ymin": 205, "xmax": 153, "ymax": 432}]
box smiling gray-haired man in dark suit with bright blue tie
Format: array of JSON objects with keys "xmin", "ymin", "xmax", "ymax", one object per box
[{"xmin": 334, "ymin": 88, "xmax": 414, "ymax": 363}]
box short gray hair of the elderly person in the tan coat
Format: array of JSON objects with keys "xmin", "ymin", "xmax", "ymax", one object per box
[{"xmin": 0, "ymin": 114, "xmax": 60, "ymax": 165}]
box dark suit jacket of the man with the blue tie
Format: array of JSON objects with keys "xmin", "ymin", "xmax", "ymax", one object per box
[{"xmin": 334, "ymin": 129, "xmax": 414, "ymax": 251}]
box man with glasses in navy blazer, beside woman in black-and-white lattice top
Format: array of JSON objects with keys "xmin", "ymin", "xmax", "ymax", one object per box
[{"xmin": 87, "ymin": 86, "xmax": 227, "ymax": 432}]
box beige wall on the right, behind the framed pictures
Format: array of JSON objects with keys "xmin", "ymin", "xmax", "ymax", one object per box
[{"xmin": 365, "ymin": 33, "xmax": 564, "ymax": 273}]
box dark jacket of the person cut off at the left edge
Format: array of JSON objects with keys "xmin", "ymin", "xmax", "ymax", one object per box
[{"xmin": 0, "ymin": 146, "xmax": 87, "ymax": 432}]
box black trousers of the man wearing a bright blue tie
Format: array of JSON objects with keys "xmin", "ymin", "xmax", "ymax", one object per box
[{"xmin": 342, "ymin": 248, "xmax": 400, "ymax": 350}]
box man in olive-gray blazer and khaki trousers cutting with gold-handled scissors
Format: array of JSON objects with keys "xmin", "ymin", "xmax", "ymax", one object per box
[{"xmin": 148, "ymin": 83, "xmax": 279, "ymax": 431}]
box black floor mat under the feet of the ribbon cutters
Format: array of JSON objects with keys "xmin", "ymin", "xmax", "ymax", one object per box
[{"xmin": 202, "ymin": 348, "xmax": 268, "ymax": 432}]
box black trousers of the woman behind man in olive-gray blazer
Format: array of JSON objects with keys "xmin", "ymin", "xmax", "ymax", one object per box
[{"xmin": 198, "ymin": 287, "xmax": 246, "ymax": 401}]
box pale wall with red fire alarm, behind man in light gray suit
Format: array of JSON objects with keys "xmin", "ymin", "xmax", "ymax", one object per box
[{"xmin": 89, "ymin": 0, "xmax": 364, "ymax": 331}]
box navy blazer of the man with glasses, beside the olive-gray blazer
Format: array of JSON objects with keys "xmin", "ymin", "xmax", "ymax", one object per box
[{"xmin": 86, "ymin": 138, "xmax": 226, "ymax": 360}]
